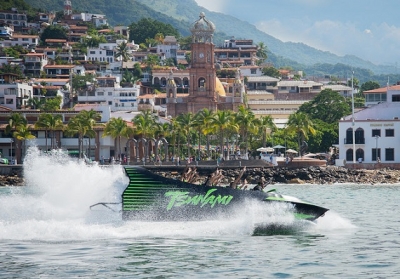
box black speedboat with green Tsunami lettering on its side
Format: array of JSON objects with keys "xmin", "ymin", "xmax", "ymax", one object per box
[{"xmin": 91, "ymin": 166, "xmax": 328, "ymax": 225}]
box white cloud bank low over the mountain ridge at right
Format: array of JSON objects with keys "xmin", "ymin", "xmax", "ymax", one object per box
[{"xmin": 256, "ymin": 18, "xmax": 400, "ymax": 64}]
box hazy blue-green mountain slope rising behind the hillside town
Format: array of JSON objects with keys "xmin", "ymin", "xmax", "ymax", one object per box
[{"xmin": 21, "ymin": 0, "xmax": 400, "ymax": 84}]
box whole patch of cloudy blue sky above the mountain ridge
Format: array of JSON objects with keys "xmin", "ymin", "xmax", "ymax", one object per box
[{"xmin": 195, "ymin": 0, "xmax": 400, "ymax": 67}]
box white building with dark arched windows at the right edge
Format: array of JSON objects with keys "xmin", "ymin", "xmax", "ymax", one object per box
[{"xmin": 338, "ymin": 85, "xmax": 400, "ymax": 169}]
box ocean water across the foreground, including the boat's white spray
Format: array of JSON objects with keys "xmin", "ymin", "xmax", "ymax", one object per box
[{"xmin": 0, "ymin": 149, "xmax": 400, "ymax": 278}]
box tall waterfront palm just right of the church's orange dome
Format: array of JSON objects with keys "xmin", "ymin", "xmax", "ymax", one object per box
[{"xmin": 235, "ymin": 106, "xmax": 258, "ymax": 160}]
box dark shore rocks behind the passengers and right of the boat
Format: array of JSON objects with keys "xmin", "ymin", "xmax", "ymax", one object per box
[{"xmin": 152, "ymin": 166, "xmax": 400, "ymax": 185}]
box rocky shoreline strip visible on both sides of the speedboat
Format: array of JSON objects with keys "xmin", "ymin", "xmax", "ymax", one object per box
[{"xmin": 0, "ymin": 165, "xmax": 400, "ymax": 187}]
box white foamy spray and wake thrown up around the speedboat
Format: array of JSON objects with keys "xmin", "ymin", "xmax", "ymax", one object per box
[{"xmin": 0, "ymin": 147, "xmax": 351, "ymax": 241}]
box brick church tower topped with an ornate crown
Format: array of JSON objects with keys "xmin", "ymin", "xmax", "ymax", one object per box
[{"xmin": 187, "ymin": 13, "xmax": 218, "ymax": 113}]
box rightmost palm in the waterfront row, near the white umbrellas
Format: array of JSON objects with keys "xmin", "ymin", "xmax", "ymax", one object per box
[{"xmin": 287, "ymin": 112, "xmax": 316, "ymax": 156}]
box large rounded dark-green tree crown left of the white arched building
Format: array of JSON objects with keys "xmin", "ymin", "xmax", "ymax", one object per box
[{"xmin": 298, "ymin": 89, "xmax": 351, "ymax": 123}]
